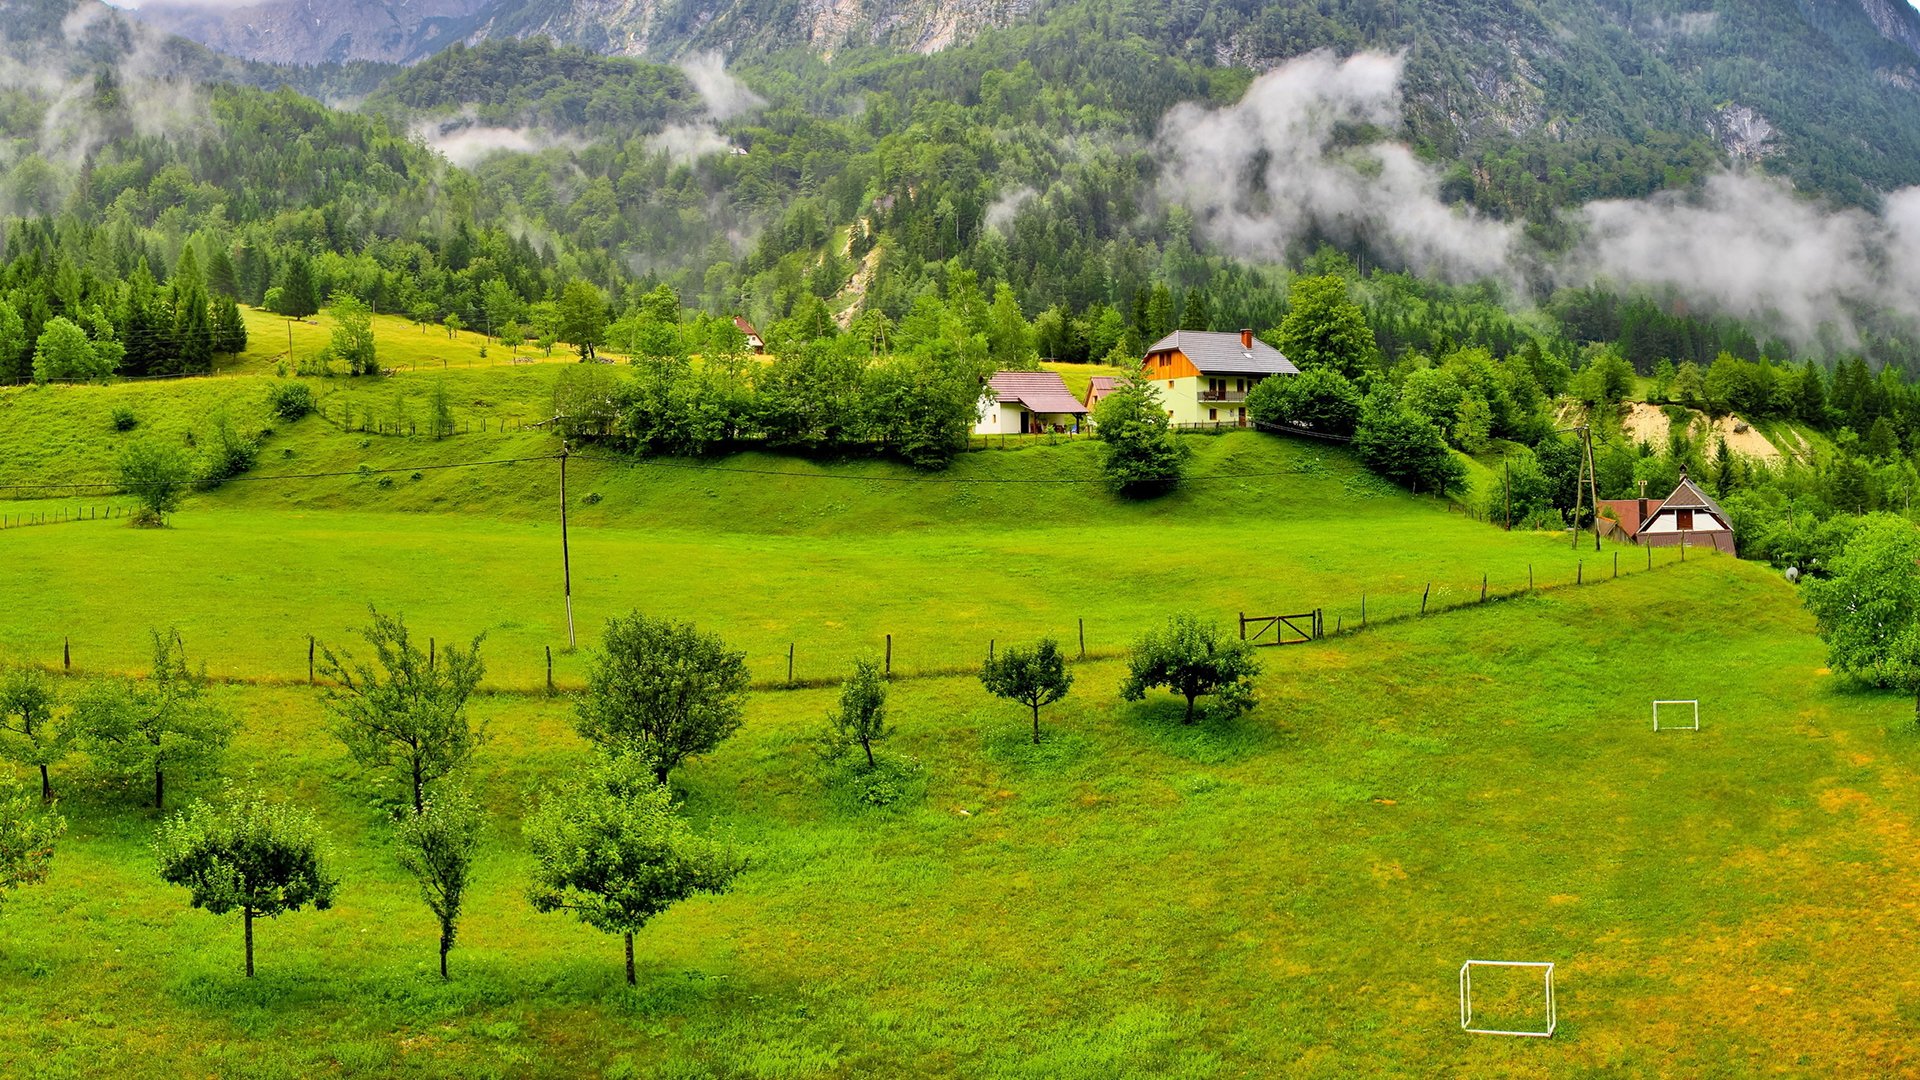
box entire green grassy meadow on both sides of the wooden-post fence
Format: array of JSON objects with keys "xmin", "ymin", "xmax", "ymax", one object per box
[{"xmin": 0, "ymin": 351, "xmax": 1920, "ymax": 1078}]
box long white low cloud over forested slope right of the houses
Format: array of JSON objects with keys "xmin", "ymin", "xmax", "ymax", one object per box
[{"xmin": 1160, "ymin": 52, "xmax": 1920, "ymax": 344}]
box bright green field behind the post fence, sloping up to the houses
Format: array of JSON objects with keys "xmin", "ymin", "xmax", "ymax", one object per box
[{"xmin": 0, "ymin": 426, "xmax": 1620, "ymax": 688}]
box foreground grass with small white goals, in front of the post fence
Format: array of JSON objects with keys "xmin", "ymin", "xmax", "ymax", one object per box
[{"xmin": 0, "ymin": 549, "xmax": 1920, "ymax": 1076}]
